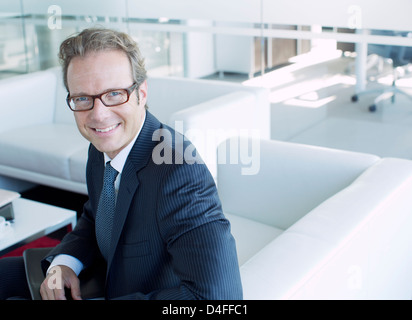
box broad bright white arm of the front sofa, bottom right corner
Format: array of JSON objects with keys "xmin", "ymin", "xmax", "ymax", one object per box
[{"xmin": 241, "ymin": 159, "xmax": 412, "ymax": 299}]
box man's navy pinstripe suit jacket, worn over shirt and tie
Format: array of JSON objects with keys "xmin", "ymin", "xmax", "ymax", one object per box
[{"xmin": 42, "ymin": 112, "xmax": 242, "ymax": 299}]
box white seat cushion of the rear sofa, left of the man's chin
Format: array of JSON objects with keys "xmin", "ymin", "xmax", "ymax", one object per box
[{"xmin": 0, "ymin": 124, "xmax": 88, "ymax": 180}]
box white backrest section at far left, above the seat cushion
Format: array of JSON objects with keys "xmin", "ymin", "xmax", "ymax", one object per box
[{"xmin": 0, "ymin": 71, "xmax": 56, "ymax": 132}]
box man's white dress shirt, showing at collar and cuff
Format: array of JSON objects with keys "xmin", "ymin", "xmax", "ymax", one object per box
[{"xmin": 47, "ymin": 113, "xmax": 146, "ymax": 275}]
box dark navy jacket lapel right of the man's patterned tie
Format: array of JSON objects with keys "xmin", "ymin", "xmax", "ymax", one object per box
[{"xmin": 107, "ymin": 111, "xmax": 161, "ymax": 272}]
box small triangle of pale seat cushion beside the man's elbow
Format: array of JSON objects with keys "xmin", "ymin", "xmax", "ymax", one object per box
[{"xmin": 225, "ymin": 213, "xmax": 283, "ymax": 265}]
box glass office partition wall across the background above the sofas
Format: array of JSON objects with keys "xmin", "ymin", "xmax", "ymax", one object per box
[{"xmin": 0, "ymin": 0, "xmax": 412, "ymax": 78}]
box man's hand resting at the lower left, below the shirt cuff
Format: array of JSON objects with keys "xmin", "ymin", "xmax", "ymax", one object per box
[{"xmin": 40, "ymin": 266, "xmax": 81, "ymax": 300}]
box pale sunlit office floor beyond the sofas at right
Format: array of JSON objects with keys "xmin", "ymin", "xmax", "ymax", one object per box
[{"xmin": 241, "ymin": 53, "xmax": 412, "ymax": 159}]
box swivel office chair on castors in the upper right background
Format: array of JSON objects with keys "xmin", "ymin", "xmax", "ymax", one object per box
[{"xmin": 352, "ymin": 31, "xmax": 412, "ymax": 112}]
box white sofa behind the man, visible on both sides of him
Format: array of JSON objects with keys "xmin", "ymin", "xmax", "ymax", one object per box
[{"xmin": 0, "ymin": 68, "xmax": 270, "ymax": 194}]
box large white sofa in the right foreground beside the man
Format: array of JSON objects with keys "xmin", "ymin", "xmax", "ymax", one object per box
[{"xmin": 217, "ymin": 138, "xmax": 412, "ymax": 299}]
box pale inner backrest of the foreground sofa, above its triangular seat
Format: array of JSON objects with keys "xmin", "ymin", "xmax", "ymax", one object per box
[{"xmin": 217, "ymin": 137, "xmax": 380, "ymax": 230}]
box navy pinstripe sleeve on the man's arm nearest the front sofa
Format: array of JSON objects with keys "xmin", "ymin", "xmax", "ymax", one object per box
[{"xmin": 115, "ymin": 164, "xmax": 242, "ymax": 300}]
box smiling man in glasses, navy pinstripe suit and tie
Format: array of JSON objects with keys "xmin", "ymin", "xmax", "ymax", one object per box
[{"xmin": 40, "ymin": 29, "xmax": 242, "ymax": 299}]
